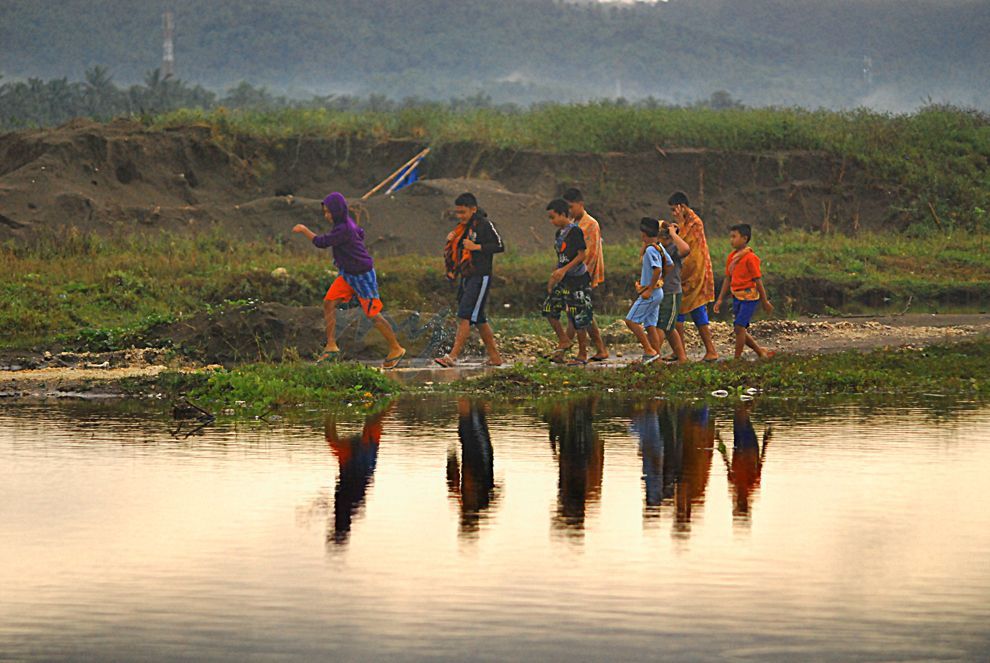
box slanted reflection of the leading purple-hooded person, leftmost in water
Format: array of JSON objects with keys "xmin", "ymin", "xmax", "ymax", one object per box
[{"xmin": 324, "ymin": 408, "xmax": 389, "ymax": 546}]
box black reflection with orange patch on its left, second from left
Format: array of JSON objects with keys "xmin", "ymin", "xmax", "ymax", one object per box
[{"xmin": 447, "ymin": 398, "xmax": 498, "ymax": 536}]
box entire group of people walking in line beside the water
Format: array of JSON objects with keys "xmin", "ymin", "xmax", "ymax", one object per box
[{"xmin": 293, "ymin": 188, "xmax": 773, "ymax": 368}]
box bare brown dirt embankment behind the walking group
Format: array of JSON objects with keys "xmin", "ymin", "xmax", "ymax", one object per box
[{"xmin": 0, "ymin": 120, "xmax": 898, "ymax": 255}]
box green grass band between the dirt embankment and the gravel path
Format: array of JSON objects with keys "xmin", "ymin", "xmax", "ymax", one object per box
[{"xmin": 0, "ymin": 229, "xmax": 990, "ymax": 351}]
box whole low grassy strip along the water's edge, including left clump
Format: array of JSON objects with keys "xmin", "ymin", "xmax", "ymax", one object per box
[{"xmin": 147, "ymin": 339, "xmax": 990, "ymax": 414}]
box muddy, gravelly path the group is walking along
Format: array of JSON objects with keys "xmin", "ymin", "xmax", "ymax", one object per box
[{"xmin": 0, "ymin": 312, "xmax": 990, "ymax": 397}]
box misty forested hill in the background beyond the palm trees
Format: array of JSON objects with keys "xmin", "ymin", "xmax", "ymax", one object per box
[{"xmin": 0, "ymin": 0, "xmax": 990, "ymax": 110}]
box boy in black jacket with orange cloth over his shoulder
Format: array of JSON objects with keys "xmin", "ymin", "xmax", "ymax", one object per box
[{"xmin": 434, "ymin": 193, "xmax": 505, "ymax": 368}]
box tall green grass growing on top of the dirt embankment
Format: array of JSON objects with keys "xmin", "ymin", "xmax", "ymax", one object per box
[{"xmin": 149, "ymin": 102, "xmax": 990, "ymax": 228}]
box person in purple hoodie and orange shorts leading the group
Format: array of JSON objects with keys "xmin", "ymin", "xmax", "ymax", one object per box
[{"xmin": 292, "ymin": 192, "xmax": 406, "ymax": 368}]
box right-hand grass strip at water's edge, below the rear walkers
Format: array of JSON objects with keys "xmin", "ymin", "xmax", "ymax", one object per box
[{"xmin": 451, "ymin": 339, "xmax": 990, "ymax": 397}]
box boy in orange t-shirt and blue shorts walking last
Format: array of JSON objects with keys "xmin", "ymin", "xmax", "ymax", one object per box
[{"xmin": 714, "ymin": 223, "xmax": 774, "ymax": 359}]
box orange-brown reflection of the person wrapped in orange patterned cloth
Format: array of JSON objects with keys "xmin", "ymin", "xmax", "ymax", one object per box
[{"xmin": 661, "ymin": 405, "xmax": 715, "ymax": 538}]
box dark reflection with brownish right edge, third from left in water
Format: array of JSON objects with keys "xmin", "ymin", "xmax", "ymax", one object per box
[{"xmin": 546, "ymin": 397, "xmax": 605, "ymax": 535}]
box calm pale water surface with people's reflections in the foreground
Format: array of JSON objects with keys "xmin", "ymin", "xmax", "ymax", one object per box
[{"xmin": 0, "ymin": 398, "xmax": 990, "ymax": 661}]
